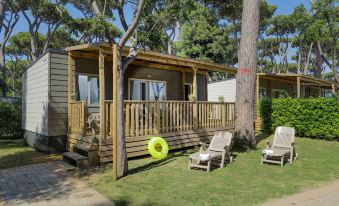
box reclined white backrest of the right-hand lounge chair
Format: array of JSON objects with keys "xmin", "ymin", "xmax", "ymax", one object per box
[{"xmin": 272, "ymin": 127, "xmax": 295, "ymax": 148}]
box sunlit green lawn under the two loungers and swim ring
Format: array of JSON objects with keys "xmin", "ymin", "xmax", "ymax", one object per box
[{"xmin": 84, "ymin": 135, "xmax": 339, "ymax": 206}]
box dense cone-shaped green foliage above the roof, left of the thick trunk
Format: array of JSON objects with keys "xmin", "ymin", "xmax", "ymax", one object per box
[{"xmin": 177, "ymin": 4, "xmax": 235, "ymax": 64}]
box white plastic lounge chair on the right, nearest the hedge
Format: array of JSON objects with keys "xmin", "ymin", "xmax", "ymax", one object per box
[{"xmin": 261, "ymin": 127, "xmax": 297, "ymax": 167}]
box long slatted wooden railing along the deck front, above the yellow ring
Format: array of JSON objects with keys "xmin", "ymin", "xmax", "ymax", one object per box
[{"xmin": 124, "ymin": 100, "xmax": 234, "ymax": 136}]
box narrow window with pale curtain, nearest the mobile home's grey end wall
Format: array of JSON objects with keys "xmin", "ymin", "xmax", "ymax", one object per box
[{"xmin": 78, "ymin": 74, "xmax": 99, "ymax": 105}]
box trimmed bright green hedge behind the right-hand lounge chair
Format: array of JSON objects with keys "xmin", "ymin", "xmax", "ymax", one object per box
[{"xmin": 260, "ymin": 98, "xmax": 339, "ymax": 140}]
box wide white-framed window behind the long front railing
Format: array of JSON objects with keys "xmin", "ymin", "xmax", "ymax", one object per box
[{"xmin": 128, "ymin": 79, "xmax": 166, "ymax": 100}]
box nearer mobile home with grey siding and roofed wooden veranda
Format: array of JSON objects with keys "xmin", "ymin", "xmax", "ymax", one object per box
[{"xmin": 23, "ymin": 44, "xmax": 236, "ymax": 162}]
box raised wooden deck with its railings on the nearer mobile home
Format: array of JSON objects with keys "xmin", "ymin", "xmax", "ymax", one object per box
[{"xmin": 67, "ymin": 101, "xmax": 235, "ymax": 163}]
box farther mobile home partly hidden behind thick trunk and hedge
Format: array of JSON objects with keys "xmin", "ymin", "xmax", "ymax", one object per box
[{"xmin": 207, "ymin": 73, "xmax": 339, "ymax": 131}]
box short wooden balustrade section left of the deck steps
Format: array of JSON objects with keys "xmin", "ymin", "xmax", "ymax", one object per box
[{"xmin": 68, "ymin": 101, "xmax": 86, "ymax": 135}]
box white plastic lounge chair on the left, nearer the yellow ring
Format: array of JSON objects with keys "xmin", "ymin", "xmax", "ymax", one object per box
[{"xmin": 188, "ymin": 132, "xmax": 233, "ymax": 172}]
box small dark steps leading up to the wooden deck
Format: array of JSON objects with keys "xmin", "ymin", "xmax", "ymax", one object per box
[{"xmin": 63, "ymin": 143, "xmax": 99, "ymax": 169}]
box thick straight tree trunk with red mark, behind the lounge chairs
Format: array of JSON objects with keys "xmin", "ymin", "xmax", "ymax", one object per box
[{"xmin": 235, "ymin": 0, "xmax": 259, "ymax": 148}]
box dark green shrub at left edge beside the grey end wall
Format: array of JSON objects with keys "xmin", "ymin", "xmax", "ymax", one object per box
[{"xmin": 0, "ymin": 101, "xmax": 21, "ymax": 136}]
